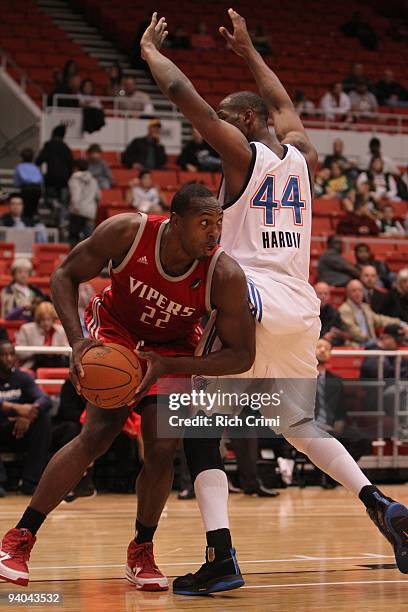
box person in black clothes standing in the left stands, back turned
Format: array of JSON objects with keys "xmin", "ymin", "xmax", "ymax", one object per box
[{"xmin": 35, "ymin": 124, "xmax": 74, "ymax": 206}]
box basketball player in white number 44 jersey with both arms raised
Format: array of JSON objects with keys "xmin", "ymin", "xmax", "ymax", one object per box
[{"xmin": 141, "ymin": 9, "xmax": 408, "ymax": 595}]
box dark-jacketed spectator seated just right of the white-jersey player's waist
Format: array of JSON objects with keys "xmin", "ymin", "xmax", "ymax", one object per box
[{"xmin": 317, "ymin": 236, "xmax": 360, "ymax": 287}]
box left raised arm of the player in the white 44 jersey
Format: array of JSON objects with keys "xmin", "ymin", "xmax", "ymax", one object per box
[{"xmin": 140, "ymin": 13, "xmax": 252, "ymax": 178}]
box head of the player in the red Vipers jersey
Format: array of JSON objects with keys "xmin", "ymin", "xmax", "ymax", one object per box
[{"xmin": 179, "ymin": 198, "xmax": 223, "ymax": 260}]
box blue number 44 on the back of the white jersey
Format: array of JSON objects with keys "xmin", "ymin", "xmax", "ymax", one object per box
[{"xmin": 250, "ymin": 174, "xmax": 306, "ymax": 227}]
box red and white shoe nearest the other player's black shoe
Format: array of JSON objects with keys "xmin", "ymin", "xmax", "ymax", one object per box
[{"xmin": 126, "ymin": 540, "xmax": 169, "ymax": 591}]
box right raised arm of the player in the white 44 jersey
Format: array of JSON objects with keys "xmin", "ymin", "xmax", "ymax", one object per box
[{"xmin": 220, "ymin": 9, "xmax": 317, "ymax": 172}]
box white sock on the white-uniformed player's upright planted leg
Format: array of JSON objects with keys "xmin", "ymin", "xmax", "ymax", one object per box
[{"xmin": 194, "ymin": 470, "xmax": 229, "ymax": 531}]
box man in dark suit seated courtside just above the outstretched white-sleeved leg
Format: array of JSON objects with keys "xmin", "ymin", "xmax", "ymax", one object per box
[{"xmin": 316, "ymin": 338, "xmax": 371, "ymax": 488}]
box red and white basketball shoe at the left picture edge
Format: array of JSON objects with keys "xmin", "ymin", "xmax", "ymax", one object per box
[{"xmin": 0, "ymin": 529, "xmax": 36, "ymax": 586}]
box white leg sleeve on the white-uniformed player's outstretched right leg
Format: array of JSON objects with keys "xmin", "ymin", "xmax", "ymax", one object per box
[{"xmin": 285, "ymin": 423, "xmax": 371, "ymax": 496}]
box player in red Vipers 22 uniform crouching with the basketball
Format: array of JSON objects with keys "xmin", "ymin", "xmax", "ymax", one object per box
[{"xmin": 0, "ymin": 184, "xmax": 255, "ymax": 591}]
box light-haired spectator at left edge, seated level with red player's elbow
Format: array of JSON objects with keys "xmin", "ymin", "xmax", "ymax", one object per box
[{"xmin": 1, "ymin": 258, "xmax": 46, "ymax": 320}]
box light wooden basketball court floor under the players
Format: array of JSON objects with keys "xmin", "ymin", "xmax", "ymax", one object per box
[{"xmin": 0, "ymin": 485, "xmax": 408, "ymax": 612}]
